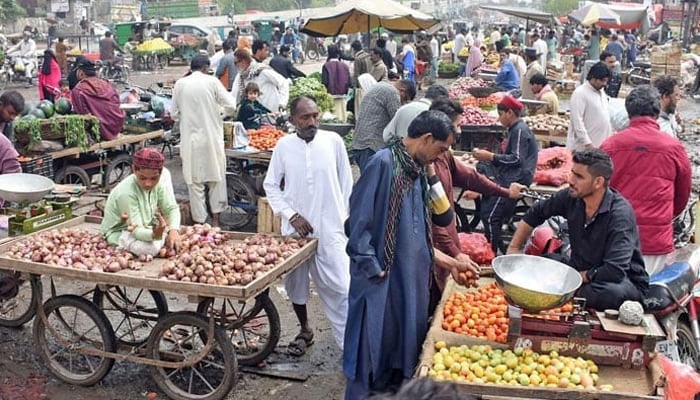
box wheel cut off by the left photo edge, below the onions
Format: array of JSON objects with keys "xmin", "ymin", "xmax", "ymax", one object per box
[{"xmin": 0, "ymin": 270, "xmax": 41, "ymax": 328}]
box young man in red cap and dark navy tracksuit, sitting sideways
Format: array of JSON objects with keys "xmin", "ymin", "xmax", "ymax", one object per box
[{"xmin": 474, "ymin": 96, "xmax": 539, "ymax": 254}]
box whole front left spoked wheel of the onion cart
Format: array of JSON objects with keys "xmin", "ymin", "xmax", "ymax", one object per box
[{"xmin": 33, "ymin": 295, "xmax": 117, "ymax": 386}]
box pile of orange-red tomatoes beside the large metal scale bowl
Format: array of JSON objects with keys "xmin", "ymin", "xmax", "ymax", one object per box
[{"xmin": 442, "ymin": 283, "xmax": 508, "ymax": 343}]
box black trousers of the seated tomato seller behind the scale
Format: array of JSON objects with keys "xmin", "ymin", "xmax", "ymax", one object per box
[{"xmin": 576, "ymin": 278, "xmax": 642, "ymax": 311}]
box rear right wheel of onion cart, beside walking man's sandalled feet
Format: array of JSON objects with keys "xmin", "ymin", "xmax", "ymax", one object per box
[{"xmin": 197, "ymin": 293, "xmax": 281, "ymax": 366}]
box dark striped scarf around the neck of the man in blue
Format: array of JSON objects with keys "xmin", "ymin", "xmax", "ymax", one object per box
[{"xmin": 384, "ymin": 138, "xmax": 433, "ymax": 273}]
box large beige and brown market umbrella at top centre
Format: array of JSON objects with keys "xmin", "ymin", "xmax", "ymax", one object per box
[{"xmin": 301, "ymin": 0, "xmax": 440, "ymax": 37}]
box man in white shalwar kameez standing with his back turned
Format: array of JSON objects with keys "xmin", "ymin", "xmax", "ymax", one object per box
[{"xmin": 171, "ymin": 55, "xmax": 236, "ymax": 226}]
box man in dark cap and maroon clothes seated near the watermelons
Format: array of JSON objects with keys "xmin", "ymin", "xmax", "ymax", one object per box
[{"xmin": 71, "ymin": 59, "xmax": 126, "ymax": 140}]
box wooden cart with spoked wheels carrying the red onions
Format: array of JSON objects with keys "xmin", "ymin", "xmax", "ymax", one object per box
[{"xmin": 0, "ymin": 216, "xmax": 317, "ymax": 400}]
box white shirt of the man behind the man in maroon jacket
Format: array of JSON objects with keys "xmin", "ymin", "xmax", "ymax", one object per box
[{"xmin": 566, "ymin": 82, "xmax": 612, "ymax": 151}]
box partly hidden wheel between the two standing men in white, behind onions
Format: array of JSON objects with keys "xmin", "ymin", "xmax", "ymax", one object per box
[{"xmin": 219, "ymin": 175, "xmax": 258, "ymax": 229}]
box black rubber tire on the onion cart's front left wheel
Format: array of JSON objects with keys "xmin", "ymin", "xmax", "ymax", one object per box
[{"xmin": 32, "ymin": 294, "xmax": 117, "ymax": 386}]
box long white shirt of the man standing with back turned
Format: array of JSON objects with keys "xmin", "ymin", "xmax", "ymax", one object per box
[{"xmin": 170, "ymin": 71, "xmax": 236, "ymax": 185}]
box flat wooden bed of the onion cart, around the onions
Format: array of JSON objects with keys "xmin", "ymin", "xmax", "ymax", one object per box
[{"xmin": 0, "ymin": 215, "xmax": 318, "ymax": 300}]
